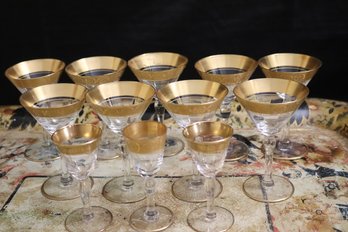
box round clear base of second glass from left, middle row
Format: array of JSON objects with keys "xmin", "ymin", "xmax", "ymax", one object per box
[{"xmin": 102, "ymin": 176, "xmax": 145, "ymax": 203}]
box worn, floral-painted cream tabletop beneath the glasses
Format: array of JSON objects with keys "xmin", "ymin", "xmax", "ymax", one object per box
[{"xmin": 0, "ymin": 98, "xmax": 348, "ymax": 232}]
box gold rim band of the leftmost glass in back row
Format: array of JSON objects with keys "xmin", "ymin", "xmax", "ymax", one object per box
[{"xmin": 5, "ymin": 58, "xmax": 65, "ymax": 89}]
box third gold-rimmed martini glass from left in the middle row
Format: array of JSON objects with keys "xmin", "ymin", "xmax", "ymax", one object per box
[{"xmin": 157, "ymin": 80, "xmax": 228, "ymax": 202}]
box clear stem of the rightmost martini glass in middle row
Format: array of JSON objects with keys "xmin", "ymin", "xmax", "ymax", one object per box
[{"xmin": 262, "ymin": 135, "xmax": 276, "ymax": 187}]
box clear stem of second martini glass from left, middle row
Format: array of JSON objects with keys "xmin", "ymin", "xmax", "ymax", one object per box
[{"xmin": 119, "ymin": 133, "xmax": 134, "ymax": 191}]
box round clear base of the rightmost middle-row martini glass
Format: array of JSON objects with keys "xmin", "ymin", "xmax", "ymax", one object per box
[{"xmin": 243, "ymin": 175, "xmax": 295, "ymax": 203}]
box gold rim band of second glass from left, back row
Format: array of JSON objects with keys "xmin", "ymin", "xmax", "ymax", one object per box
[{"xmin": 65, "ymin": 56, "xmax": 127, "ymax": 86}]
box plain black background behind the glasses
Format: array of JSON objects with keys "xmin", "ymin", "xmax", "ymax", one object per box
[{"xmin": 0, "ymin": 0, "xmax": 348, "ymax": 105}]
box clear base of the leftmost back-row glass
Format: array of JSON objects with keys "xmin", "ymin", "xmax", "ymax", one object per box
[{"xmin": 24, "ymin": 142, "xmax": 60, "ymax": 162}]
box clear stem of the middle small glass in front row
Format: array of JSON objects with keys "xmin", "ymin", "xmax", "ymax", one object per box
[{"xmin": 144, "ymin": 176, "xmax": 158, "ymax": 221}]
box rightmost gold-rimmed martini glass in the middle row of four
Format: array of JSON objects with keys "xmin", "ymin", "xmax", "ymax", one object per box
[{"xmin": 234, "ymin": 78, "xmax": 309, "ymax": 202}]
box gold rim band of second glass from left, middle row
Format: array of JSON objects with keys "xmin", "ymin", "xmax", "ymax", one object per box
[{"xmin": 86, "ymin": 81, "xmax": 155, "ymax": 117}]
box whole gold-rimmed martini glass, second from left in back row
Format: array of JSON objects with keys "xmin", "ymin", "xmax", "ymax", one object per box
[{"xmin": 65, "ymin": 56, "xmax": 127, "ymax": 160}]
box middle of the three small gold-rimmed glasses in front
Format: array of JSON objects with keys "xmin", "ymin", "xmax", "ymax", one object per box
[{"xmin": 123, "ymin": 121, "xmax": 174, "ymax": 231}]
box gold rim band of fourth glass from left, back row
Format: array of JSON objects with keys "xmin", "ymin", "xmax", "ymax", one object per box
[{"xmin": 194, "ymin": 54, "xmax": 257, "ymax": 85}]
